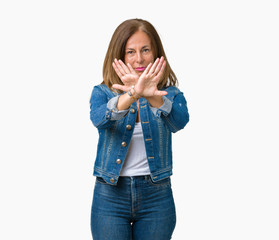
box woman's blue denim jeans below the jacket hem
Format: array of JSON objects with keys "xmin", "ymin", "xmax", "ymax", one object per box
[{"xmin": 91, "ymin": 176, "xmax": 176, "ymax": 240}]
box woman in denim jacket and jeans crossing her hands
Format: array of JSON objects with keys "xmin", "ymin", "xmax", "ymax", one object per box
[{"xmin": 90, "ymin": 19, "xmax": 189, "ymax": 240}]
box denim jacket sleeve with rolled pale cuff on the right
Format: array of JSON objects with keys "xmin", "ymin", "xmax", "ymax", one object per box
[{"xmin": 150, "ymin": 88, "xmax": 189, "ymax": 133}]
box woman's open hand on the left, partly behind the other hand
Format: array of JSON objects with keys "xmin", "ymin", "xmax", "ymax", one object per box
[{"xmin": 112, "ymin": 59, "xmax": 139, "ymax": 92}]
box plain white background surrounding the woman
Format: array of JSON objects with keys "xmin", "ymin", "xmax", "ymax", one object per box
[{"xmin": 0, "ymin": 0, "xmax": 279, "ymax": 240}]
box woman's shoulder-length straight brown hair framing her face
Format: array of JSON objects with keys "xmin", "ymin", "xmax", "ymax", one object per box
[{"xmin": 102, "ymin": 19, "xmax": 178, "ymax": 89}]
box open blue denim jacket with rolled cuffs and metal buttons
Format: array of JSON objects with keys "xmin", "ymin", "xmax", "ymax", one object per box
[{"xmin": 90, "ymin": 84, "xmax": 189, "ymax": 185}]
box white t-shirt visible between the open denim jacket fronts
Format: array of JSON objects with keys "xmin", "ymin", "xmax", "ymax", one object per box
[{"xmin": 120, "ymin": 122, "xmax": 150, "ymax": 177}]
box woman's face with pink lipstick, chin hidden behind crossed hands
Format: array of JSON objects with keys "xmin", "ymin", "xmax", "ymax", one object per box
[{"xmin": 124, "ymin": 30, "xmax": 154, "ymax": 75}]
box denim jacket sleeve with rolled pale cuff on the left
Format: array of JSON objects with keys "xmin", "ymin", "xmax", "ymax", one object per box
[{"xmin": 90, "ymin": 85, "xmax": 128, "ymax": 128}]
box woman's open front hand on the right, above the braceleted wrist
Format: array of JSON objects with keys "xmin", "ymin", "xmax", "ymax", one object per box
[{"xmin": 134, "ymin": 57, "xmax": 168, "ymax": 98}]
